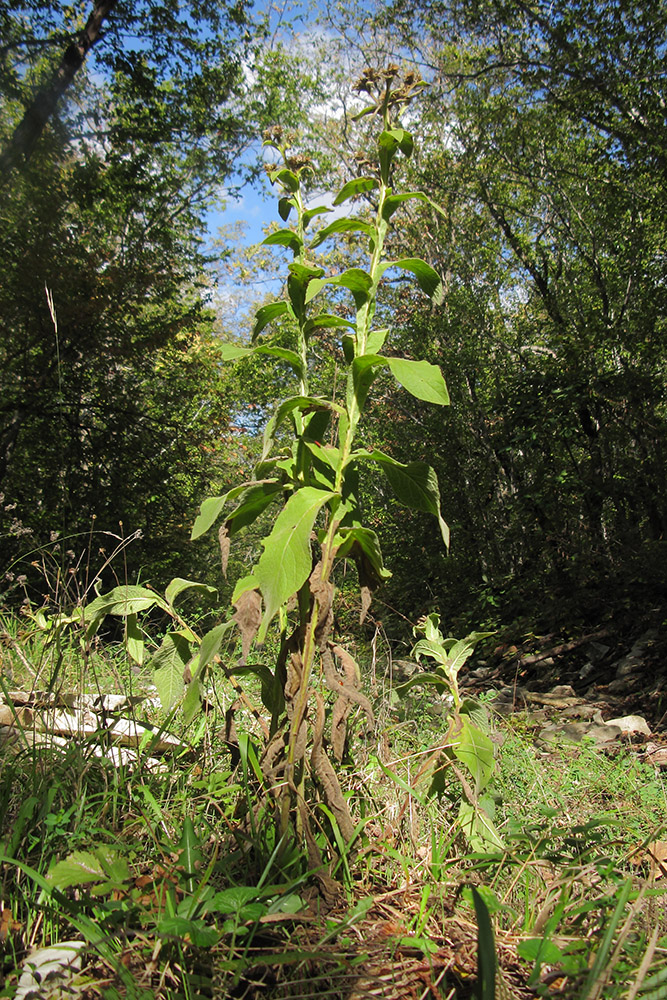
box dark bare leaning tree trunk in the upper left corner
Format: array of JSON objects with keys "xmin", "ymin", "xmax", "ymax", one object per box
[{"xmin": 0, "ymin": 0, "xmax": 116, "ymax": 180}]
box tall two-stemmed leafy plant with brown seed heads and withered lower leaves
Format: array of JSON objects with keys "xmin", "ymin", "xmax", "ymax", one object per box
[{"xmin": 82, "ymin": 69, "xmax": 448, "ymax": 866}]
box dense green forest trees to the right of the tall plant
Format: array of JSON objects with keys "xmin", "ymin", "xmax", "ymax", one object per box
[{"xmin": 302, "ymin": 0, "xmax": 667, "ymax": 634}]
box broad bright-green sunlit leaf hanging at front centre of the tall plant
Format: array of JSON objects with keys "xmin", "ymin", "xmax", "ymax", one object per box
[{"xmin": 255, "ymin": 486, "xmax": 336, "ymax": 642}]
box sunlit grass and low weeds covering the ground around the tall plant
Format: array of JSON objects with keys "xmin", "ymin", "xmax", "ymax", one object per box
[{"xmin": 0, "ymin": 618, "xmax": 667, "ymax": 1000}]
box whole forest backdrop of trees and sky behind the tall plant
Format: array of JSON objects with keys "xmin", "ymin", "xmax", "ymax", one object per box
[{"xmin": 0, "ymin": 0, "xmax": 667, "ymax": 637}]
